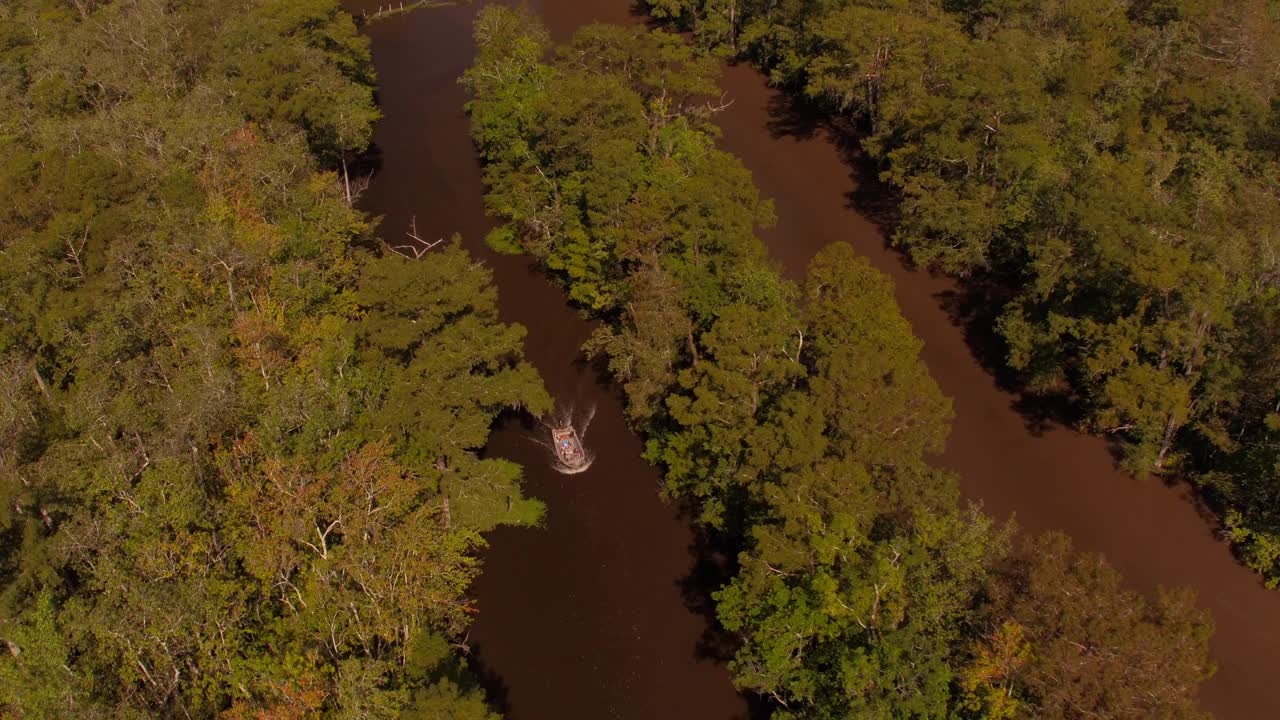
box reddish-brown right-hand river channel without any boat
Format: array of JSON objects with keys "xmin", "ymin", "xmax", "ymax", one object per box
[{"xmin": 718, "ymin": 58, "xmax": 1280, "ymax": 719}]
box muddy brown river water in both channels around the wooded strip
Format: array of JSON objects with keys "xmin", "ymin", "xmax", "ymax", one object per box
[{"xmin": 346, "ymin": 0, "xmax": 1280, "ymax": 720}]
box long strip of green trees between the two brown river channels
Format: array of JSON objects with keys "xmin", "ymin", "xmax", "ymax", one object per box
[{"xmin": 463, "ymin": 3, "xmax": 1212, "ymax": 719}]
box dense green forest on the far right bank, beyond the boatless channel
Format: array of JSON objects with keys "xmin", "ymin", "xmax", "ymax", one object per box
[{"xmin": 648, "ymin": 0, "xmax": 1280, "ymax": 585}]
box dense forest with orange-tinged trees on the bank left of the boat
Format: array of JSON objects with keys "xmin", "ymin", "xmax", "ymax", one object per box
[{"xmin": 0, "ymin": 0, "xmax": 549, "ymax": 719}]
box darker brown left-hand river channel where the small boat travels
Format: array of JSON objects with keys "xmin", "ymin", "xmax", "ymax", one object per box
[{"xmin": 348, "ymin": 3, "xmax": 749, "ymax": 720}]
